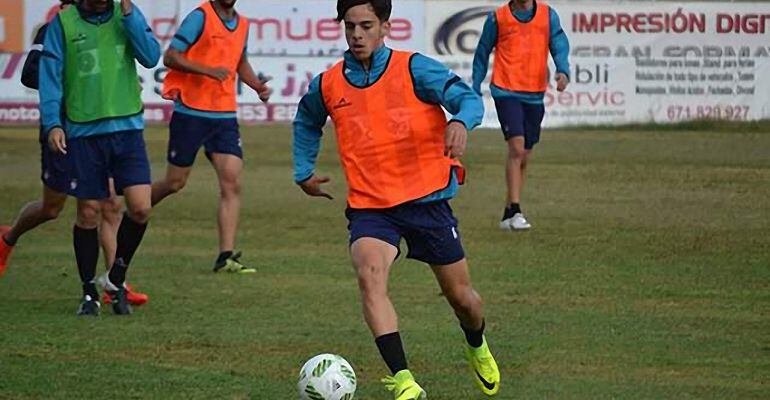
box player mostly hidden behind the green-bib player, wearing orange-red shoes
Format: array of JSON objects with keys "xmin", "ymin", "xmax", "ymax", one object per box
[{"xmin": 0, "ymin": 0, "xmax": 149, "ymax": 305}]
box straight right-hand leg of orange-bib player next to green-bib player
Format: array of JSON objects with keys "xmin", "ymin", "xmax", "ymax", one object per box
[{"xmin": 204, "ymin": 118, "xmax": 250, "ymax": 274}]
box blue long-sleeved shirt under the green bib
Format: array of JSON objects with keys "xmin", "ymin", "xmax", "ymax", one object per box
[{"xmin": 39, "ymin": 4, "xmax": 160, "ymax": 138}]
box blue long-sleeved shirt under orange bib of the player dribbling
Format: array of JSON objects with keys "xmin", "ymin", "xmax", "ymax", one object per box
[{"xmin": 294, "ymin": 46, "xmax": 484, "ymax": 202}]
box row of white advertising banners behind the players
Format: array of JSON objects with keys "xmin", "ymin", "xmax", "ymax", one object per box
[{"xmin": 0, "ymin": 0, "xmax": 770, "ymax": 127}]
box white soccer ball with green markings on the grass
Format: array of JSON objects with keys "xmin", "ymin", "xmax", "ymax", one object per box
[{"xmin": 297, "ymin": 354, "xmax": 356, "ymax": 400}]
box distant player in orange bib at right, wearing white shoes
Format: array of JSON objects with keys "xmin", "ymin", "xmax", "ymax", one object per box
[{"xmin": 473, "ymin": 0, "xmax": 569, "ymax": 230}]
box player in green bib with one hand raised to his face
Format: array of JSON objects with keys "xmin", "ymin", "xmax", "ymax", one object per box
[{"xmin": 39, "ymin": 0, "xmax": 160, "ymax": 316}]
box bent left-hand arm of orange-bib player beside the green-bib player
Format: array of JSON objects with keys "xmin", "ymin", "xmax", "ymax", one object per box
[{"xmin": 163, "ymin": 10, "xmax": 230, "ymax": 81}]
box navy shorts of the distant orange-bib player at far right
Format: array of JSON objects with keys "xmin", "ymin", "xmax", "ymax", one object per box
[{"xmin": 494, "ymin": 97, "xmax": 545, "ymax": 150}]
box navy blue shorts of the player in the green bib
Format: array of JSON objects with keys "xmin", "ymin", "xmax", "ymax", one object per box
[{"xmin": 67, "ymin": 131, "xmax": 152, "ymax": 200}]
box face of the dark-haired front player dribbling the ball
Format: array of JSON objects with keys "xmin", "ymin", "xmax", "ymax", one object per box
[{"xmin": 345, "ymin": 3, "xmax": 390, "ymax": 60}]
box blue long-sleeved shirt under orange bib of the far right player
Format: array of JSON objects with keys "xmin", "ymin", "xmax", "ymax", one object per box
[{"xmin": 473, "ymin": 7, "xmax": 569, "ymax": 104}]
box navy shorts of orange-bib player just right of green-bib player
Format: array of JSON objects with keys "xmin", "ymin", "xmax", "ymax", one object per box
[{"xmin": 167, "ymin": 112, "xmax": 243, "ymax": 167}]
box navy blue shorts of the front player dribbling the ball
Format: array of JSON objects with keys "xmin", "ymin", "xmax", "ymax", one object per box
[{"xmin": 345, "ymin": 200, "xmax": 465, "ymax": 265}]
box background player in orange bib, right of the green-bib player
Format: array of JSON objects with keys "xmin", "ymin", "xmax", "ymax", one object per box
[{"xmin": 152, "ymin": 0, "xmax": 270, "ymax": 273}]
